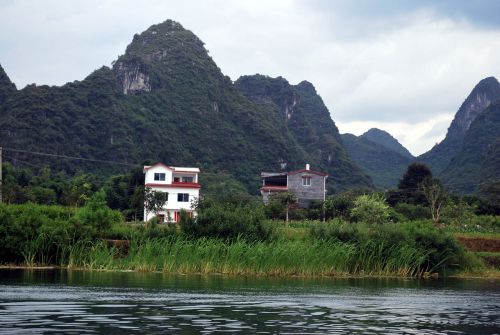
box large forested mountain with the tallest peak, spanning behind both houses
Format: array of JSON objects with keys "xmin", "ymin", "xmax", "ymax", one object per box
[{"xmin": 0, "ymin": 20, "xmax": 371, "ymax": 192}]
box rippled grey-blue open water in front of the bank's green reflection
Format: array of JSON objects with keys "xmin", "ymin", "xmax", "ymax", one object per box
[{"xmin": 0, "ymin": 285, "xmax": 500, "ymax": 334}]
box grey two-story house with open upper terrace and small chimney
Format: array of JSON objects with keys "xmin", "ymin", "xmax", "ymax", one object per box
[{"xmin": 260, "ymin": 164, "xmax": 328, "ymax": 208}]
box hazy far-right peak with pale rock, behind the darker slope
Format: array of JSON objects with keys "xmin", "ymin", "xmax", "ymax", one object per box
[{"xmin": 418, "ymin": 77, "xmax": 500, "ymax": 176}]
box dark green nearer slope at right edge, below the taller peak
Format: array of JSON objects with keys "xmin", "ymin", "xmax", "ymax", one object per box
[{"xmin": 442, "ymin": 101, "xmax": 500, "ymax": 193}]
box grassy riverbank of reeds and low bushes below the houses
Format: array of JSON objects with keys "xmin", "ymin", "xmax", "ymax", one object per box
[{"xmin": 0, "ymin": 205, "xmax": 489, "ymax": 277}]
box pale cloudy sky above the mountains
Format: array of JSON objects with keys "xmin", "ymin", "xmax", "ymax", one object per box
[{"xmin": 0, "ymin": 0, "xmax": 500, "ymax": 155}]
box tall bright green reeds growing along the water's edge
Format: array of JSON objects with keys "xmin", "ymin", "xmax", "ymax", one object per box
[{"xmin": 61, "ymin": 235, "xmax": 430, "ymax": 277}]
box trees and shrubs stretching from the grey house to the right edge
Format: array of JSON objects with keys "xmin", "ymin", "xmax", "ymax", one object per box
[{"xmin": 265, "ymin": 163, "xmax": 500, "ymax": 231}]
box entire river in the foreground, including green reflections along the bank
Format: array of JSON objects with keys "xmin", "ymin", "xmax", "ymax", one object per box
[{"xmin": 0, "ymin": 270, "xmax": 500, "ymax": 335}]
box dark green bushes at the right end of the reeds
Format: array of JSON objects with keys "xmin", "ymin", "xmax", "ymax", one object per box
[{"xmin": 310, "ymin": 221, "xmax": 474, "ymax": 276}]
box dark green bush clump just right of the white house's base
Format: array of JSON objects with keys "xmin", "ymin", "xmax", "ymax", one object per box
[{"xmin": 180, "ymin": 200, "xmax": 272, "ymax": 240}]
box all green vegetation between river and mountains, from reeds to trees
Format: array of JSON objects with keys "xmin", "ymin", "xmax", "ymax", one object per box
[{"xmin": 0, "ymin": 166, "xmax": 500, "ymax": 277}]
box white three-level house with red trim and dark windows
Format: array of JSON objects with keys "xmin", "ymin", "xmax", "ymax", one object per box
[{"xmin": 144, "ymin": 163, "xmax": 201, "ymax": 222}]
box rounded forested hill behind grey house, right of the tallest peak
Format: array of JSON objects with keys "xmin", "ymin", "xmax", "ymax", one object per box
[{"xmin": 235, "ymin": 75, "xmax": 371, "ymax": 192}]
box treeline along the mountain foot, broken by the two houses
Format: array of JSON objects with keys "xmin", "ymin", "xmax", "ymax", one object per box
[{"xmin": 2, "ymin": 163, "xmax": 500, "ymax": 228}]
